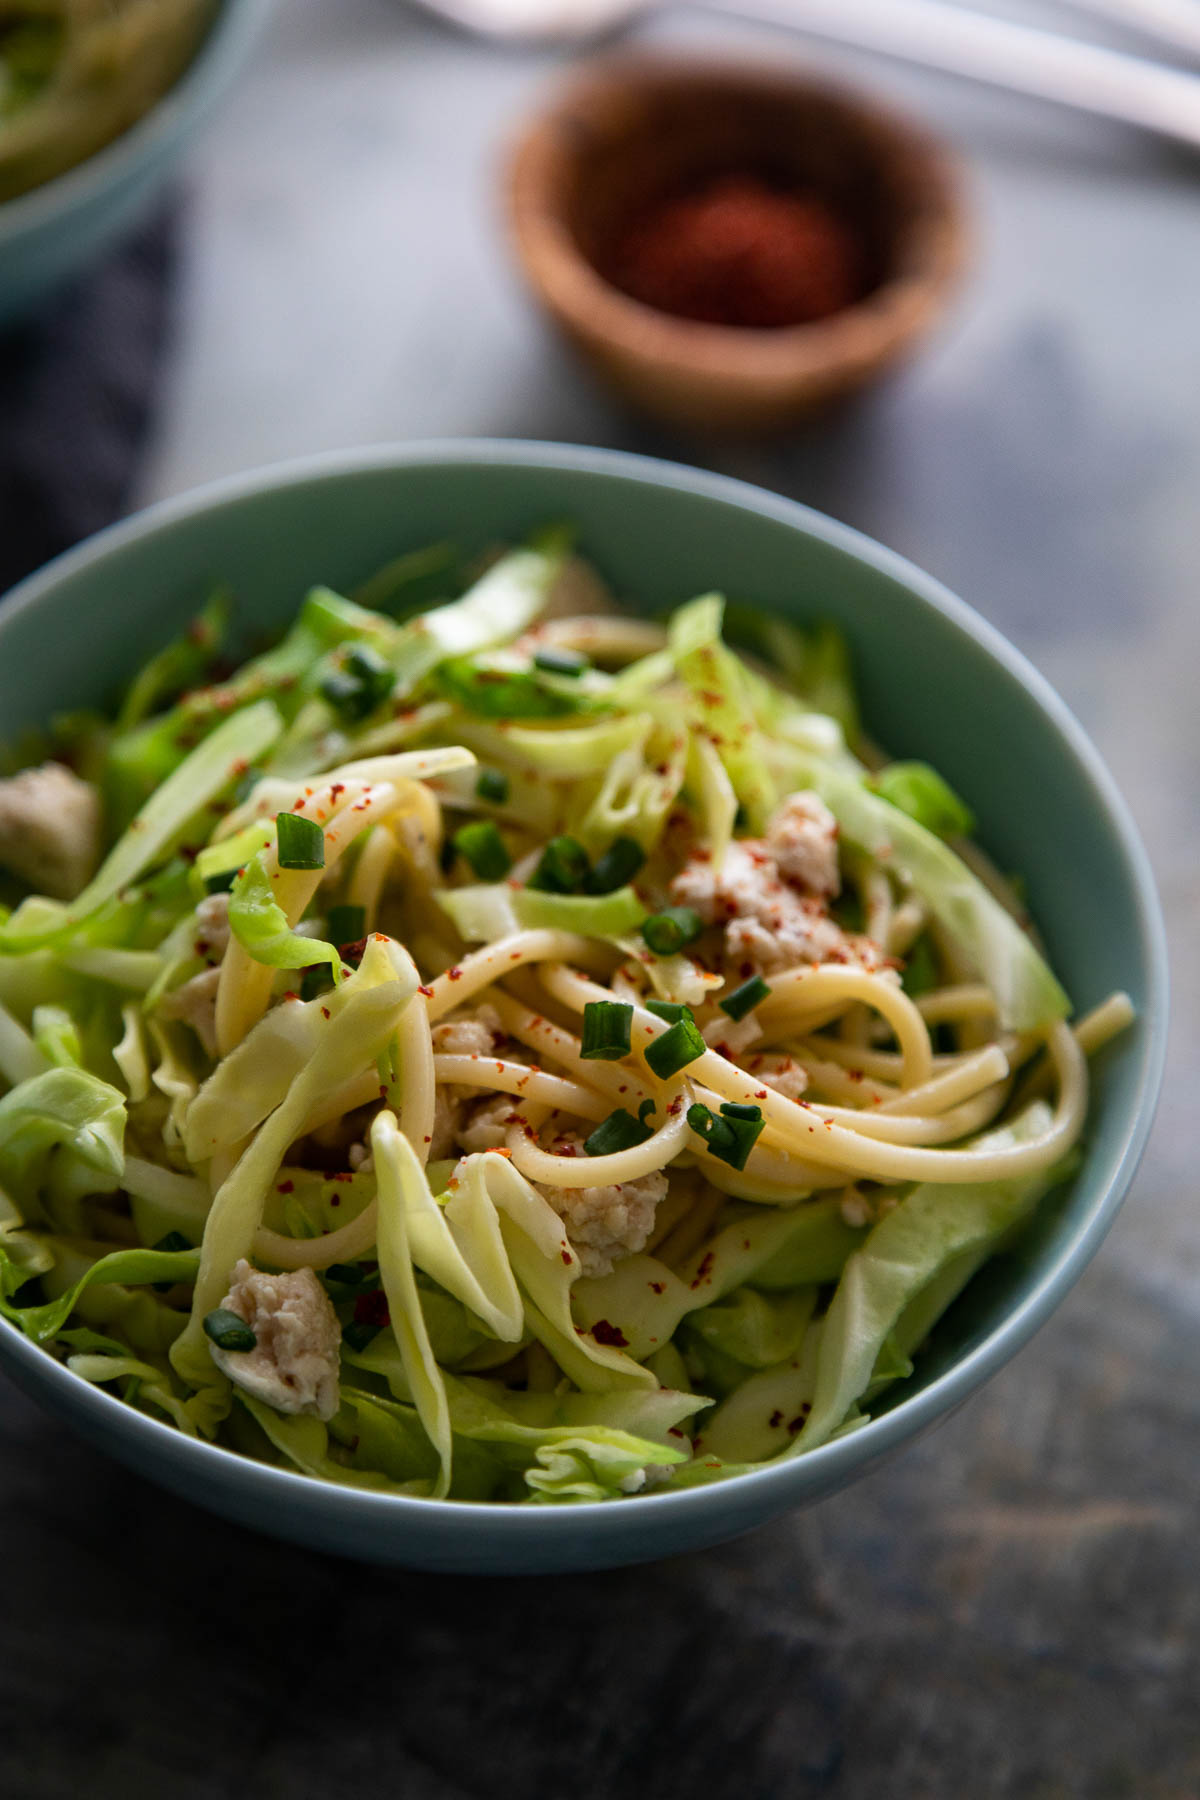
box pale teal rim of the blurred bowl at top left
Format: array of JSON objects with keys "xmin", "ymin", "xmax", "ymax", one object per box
[{"xmin": 0, "ymin": 0, "xmax": 275, "ymax": 250}]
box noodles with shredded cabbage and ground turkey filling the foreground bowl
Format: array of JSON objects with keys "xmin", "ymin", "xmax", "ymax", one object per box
[{"xmin": 0, "ymin": 535, "xmax": 1132, "ymax": 1505}]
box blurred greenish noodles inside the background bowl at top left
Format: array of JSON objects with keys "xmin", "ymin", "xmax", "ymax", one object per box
[{"xmin": 0, "ymin": 0, "xmax": 214, "ymax": 202}]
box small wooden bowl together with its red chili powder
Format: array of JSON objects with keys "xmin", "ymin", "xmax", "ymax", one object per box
[{"xmin": 509, "ymin": 58, "xmax": 966, "ymax": 434}]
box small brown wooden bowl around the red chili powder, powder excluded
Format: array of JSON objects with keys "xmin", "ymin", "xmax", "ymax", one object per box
[{"xmin": 509, "ymin": 58, "xmax": 966, "ymax": 434}]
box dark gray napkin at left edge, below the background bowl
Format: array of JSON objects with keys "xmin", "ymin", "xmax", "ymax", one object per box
[{"xmin": 0, "ymin": 207, "xmax": 178, "ymax": 594}]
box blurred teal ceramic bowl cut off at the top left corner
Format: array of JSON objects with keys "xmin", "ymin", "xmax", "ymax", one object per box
[{"xmin": 0, "ymin": 0, "xmax": 273, "ymax": 326}]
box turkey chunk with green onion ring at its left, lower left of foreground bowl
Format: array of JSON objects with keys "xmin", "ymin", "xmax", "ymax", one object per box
[{"xmin": 209, "ymin": 1256, "xmax": 342, "ymax": 1420}]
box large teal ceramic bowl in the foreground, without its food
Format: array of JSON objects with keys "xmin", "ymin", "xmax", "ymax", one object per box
[{"xmin": 0, "ymin": 443, "xmax": 1166, "ymax": 1571}]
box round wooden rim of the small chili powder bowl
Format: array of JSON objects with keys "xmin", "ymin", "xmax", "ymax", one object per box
[{"xmin": 504, "ymin": 49, "xmax": 970, "ymax": 383}]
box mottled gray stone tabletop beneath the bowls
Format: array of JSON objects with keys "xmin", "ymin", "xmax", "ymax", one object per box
[{"xmin": 0, "ymin": 0, "xmax": 1200, "ymax": 1800}]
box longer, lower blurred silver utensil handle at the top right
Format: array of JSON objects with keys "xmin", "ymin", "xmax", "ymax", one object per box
[{"xmin": 703, "ymin": 0, "xmax": 1200, "ymax": 148}]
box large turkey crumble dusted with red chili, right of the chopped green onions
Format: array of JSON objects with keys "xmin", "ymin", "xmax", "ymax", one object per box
[{"xmin": 671, "ymin": 792, "xmax": 883, "ymax": 979}]
